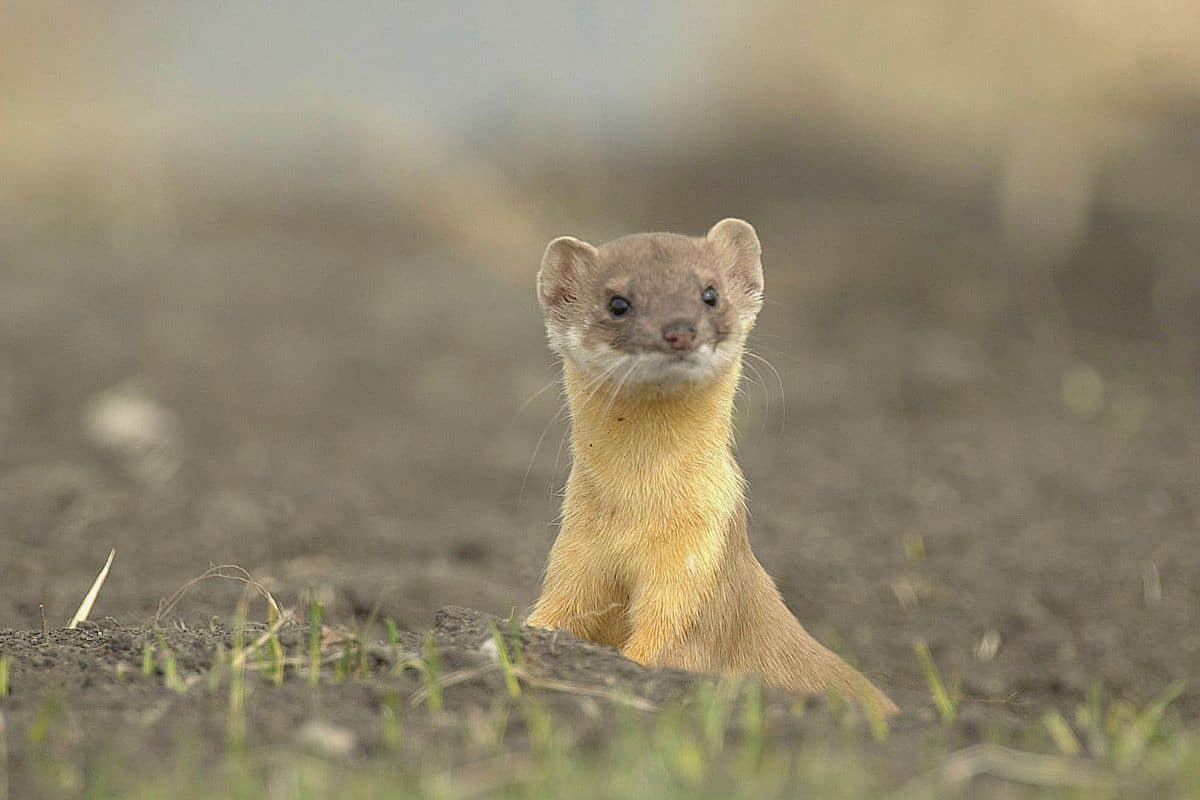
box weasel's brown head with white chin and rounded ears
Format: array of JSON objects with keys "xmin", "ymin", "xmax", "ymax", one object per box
[{"xmin": 538, "ymin": 218, "xmax": 762, "ymax": 391}]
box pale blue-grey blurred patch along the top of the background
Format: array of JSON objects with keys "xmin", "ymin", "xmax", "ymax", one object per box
[{"xmin": 116, "ymin": 0, "xmax": 719, "ymax": 133}]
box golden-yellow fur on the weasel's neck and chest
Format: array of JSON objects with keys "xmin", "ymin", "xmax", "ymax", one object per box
[{"xmin": 562, "ymin": 366, "xmax": 743, "ymax": 583}]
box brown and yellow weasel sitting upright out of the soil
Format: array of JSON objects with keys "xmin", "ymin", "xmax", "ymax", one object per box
[{"xmin": 527, "ymin": 218, "xmax": 898, "ymax": 715}]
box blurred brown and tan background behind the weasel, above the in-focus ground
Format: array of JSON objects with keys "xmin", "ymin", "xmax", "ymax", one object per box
[{"xmin": 0, "ymin": 0, "xmax": 1200, "ymax": 669}]
